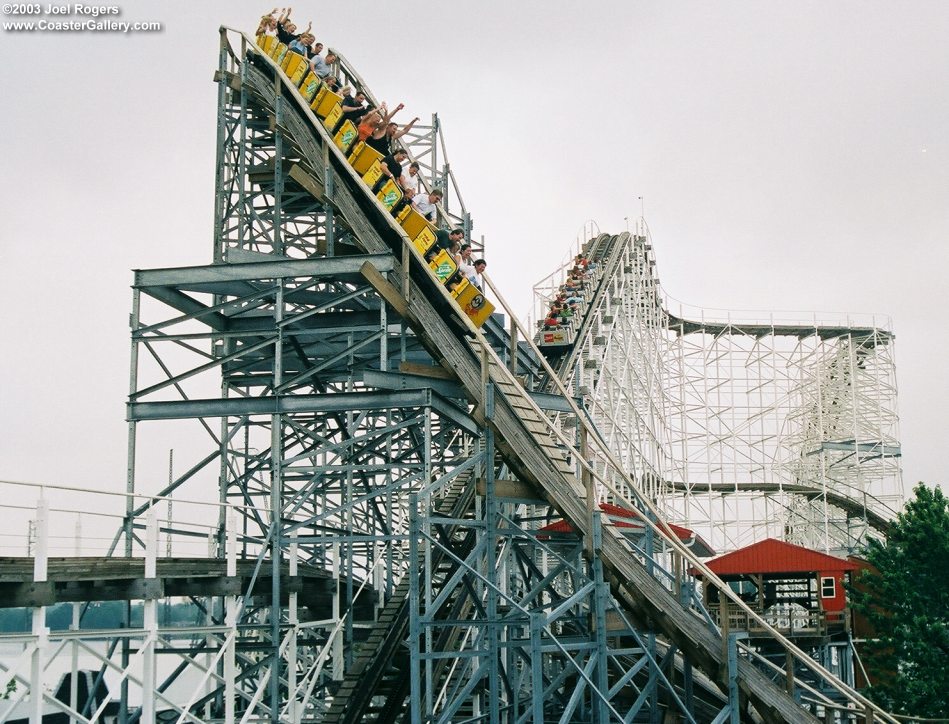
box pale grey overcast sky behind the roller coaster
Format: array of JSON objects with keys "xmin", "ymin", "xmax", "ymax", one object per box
[{"xmin": 0, "ymin": 0, "xmax": 949, "ymax": 504}]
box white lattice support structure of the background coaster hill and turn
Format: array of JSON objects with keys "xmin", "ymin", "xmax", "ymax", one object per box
[{"xmin": 535, "ymin": 233, "xmax": 903, "ymax": 555}]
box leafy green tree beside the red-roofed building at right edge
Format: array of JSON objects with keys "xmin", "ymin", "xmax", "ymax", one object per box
[{"xmin": 850, "ymin": 483, "xmax": 949, "ymax": 717}]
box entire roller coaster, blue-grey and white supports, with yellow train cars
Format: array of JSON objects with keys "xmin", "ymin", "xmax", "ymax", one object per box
[{"xmin": 0, "ymin": 28, "xmax": 901, "ymax": 723}]
